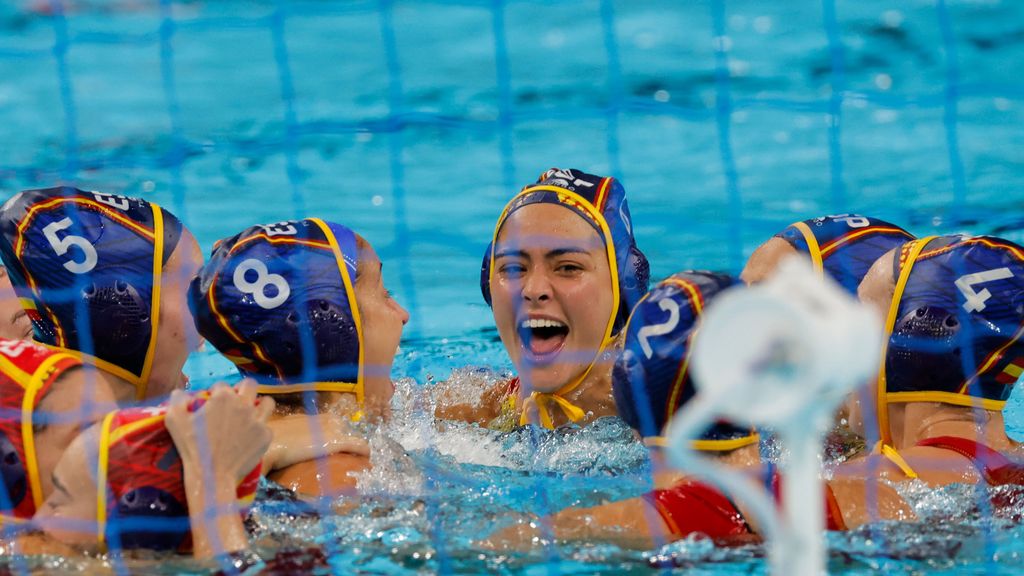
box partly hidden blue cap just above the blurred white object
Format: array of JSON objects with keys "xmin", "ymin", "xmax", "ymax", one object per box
[{"xmin": 775, "ymin": 214, "xmax": 913, "ymax": 294}]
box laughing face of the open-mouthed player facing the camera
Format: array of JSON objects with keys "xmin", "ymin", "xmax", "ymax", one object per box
[{"xmin": 490, "ymin": 204, "xmax": 613, "ymax": 393}]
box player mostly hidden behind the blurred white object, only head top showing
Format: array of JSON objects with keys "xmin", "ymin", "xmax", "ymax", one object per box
[{"xmin": 740, "ymin": 214, "xmax": 913, "ymax": 294}]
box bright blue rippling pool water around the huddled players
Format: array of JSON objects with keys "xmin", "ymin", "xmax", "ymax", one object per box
[{"xmin": 0, "ymin": 0, "xmax": 1024, "ymax": 574}]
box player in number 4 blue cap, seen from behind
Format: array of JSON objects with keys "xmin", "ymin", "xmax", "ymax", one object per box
[{"xmin": 846, "ymin": 236, "xmax": 1024, "ymax": 485}]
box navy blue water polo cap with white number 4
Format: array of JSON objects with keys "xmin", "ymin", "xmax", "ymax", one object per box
[{"xmin": 878, "ymin": 236, "xmax": 1024, "ymax": 441}]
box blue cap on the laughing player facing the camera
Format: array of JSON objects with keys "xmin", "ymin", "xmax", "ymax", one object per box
[{"xmin": 480, "ymin": 168, "xmax": 650, "ymax": 334}]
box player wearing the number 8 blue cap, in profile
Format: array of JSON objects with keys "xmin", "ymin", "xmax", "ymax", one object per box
[{"xmin": 189, "ymin": 218, "xmax": 409, "ymax": 495}]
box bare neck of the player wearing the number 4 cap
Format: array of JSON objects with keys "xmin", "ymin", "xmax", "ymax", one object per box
[{"xmin": 889, "ymin": 402, "xmax": 1017, "ymax": 451}]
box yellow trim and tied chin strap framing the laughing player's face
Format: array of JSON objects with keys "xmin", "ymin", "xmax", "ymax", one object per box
[{"xmin": 489, "ymin": 186, "xmax": 621, "ymax": 428}]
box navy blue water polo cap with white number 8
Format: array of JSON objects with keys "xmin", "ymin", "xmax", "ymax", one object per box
[{"xmin": 188, "ymin": 218, "xmax": 364, "ymax": 405}]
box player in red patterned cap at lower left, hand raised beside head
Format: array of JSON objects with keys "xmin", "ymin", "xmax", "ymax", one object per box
[{"xmin": 30, "ymin": 381, "xmax": 273, "ymax": 558}]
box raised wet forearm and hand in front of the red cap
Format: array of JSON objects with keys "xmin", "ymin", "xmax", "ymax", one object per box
[{"xmin": 166, "ymin": 381, "xmax": 273, "ymax": 558}]
